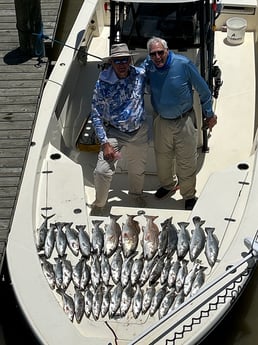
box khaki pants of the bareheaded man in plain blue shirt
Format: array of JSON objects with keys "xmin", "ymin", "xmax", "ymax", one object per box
[{"xmin": 154, "ymin": 111, "xmax": 197, "ymax": 199}]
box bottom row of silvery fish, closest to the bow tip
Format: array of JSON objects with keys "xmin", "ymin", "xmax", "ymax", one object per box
[{"xmin": 57, "ymin": 270, "xmax": 204, "ymax": 323}]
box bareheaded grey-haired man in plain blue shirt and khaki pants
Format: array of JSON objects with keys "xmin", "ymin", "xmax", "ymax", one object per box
[{"xmin": 144, "ymin": 37, "xmax": 217, "ymax": 210}]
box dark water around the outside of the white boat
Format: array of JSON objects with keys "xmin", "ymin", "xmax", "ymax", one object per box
[{"xmin": 0, "ymin": 0, "xmax": 258, "ymax": 345}]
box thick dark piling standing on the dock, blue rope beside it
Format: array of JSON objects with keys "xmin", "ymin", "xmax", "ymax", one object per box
[{"xmin": 14, "ymin": 0, "xmax": 45, "ymax": 57}]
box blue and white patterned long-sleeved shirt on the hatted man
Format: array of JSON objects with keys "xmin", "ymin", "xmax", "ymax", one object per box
[{"xmin": 91, "ymin": 66, "xmax": 145, "ymax": 144}]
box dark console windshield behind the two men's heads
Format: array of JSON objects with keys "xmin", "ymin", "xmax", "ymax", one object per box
[{"xmin": 111, "ymin": 2, "xmax": 200, "ymax": 49}]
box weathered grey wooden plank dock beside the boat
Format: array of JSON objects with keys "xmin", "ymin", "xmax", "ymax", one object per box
[{"xmin": 0, "ymin": 0, "xmax": 62, "ymax": 272}]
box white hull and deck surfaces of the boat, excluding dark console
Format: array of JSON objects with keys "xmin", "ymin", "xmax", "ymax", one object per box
[{"xmin": 7, "ymin": 0, "xmax": 258, "ymax": 345}]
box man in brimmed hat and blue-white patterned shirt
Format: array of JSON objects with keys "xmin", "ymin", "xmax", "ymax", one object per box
[{"xmin": 91, "ymin": 43, "xmax": 148, "ymax": 215}]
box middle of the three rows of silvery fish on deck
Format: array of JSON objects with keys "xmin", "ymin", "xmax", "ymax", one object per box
[{"xmin": 39, "ymin": 248, "xmax": 206, "ymax": 296}]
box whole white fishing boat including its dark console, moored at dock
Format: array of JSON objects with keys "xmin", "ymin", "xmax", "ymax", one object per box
[{"xmin": 7, "ymin": 0, "xmax": 258, "ymax": 345}]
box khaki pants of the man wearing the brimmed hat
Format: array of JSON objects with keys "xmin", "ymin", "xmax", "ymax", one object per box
[{"xmin": 94, "ymin": 123, "xmax": 148, "ymax": 207}]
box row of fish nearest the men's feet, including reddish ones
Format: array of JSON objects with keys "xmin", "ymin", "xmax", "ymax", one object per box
[{"xmin": 36, "ymin": 215, "xmax": 219, "ymax": 267}]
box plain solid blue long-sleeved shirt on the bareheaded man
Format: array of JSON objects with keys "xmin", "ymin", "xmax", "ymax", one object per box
[{"xmin": 143, "ymin": 52, "xmax": 214, "ymax": 119}]
